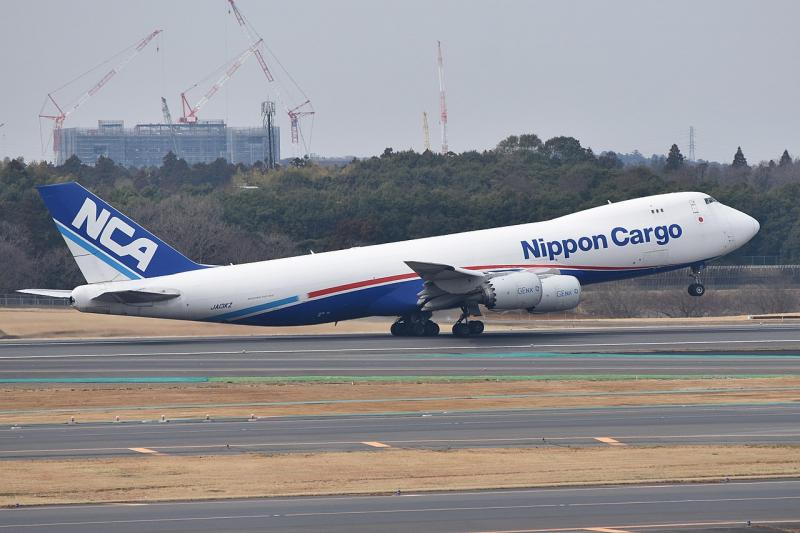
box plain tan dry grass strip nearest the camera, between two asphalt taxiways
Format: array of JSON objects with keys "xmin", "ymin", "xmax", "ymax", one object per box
[{"xmin": 0, "ymin": 446, "xmax": 800, "ymax": 505}]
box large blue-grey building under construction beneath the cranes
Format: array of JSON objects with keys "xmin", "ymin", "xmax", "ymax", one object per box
[{"xmin": 55, "ymin": 120, "xmax": 280, "ymax": 167}]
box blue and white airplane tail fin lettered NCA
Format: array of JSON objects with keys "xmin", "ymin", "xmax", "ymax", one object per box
[{"xmin": 38, "ymin": 182, "xmax": 205, "ymax": 283}]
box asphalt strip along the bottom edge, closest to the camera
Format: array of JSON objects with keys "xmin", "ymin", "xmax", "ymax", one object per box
[{"xmin": 0, "ymin": 480, "xmax": 800, "ymax": 533}]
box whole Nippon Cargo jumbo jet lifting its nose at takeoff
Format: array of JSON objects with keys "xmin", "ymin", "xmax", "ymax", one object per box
[{"xmin": 21, "ymin": 183, "xmax": 759, "ymax": 336}]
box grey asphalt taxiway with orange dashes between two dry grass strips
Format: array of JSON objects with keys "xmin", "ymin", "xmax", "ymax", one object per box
[{"xmin": 6, "ymin": 404, "xmax": 800, "ymax": 458}]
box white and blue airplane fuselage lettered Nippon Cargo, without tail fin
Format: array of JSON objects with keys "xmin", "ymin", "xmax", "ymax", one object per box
[{"xmin": 67, "ymin": 192, "xmax": 758, "ymax": 325}]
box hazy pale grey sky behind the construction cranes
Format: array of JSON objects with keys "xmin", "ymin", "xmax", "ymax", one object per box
[{"xmin": 0, "ymin": 0, "xmax": 800, "ymax": 162}]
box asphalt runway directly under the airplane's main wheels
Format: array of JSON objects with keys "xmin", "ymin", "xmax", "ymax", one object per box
[{"xmin": 0, "ymin": 324, "xmax": 800, "ymax": 379}]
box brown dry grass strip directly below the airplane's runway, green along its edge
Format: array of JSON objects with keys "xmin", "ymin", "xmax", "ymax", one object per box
[{"xmin": 0, "ymin": 377, "xmax": 800, "ymax": 424}]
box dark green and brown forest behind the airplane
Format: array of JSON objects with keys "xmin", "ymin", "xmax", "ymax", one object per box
[{"xmin": 0, "ymin": 134, "xmax": 800, "ymax": 290}]
